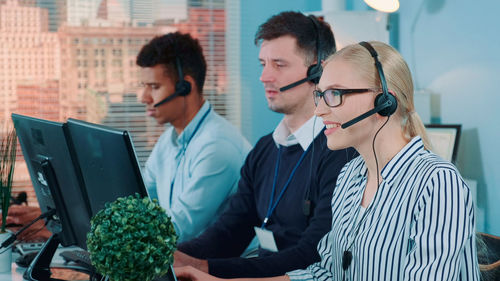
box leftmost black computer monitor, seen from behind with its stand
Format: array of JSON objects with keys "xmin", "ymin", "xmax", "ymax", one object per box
[{"xmin": 12, "ymin": 114, "xmax": 90, "ymax": 249}]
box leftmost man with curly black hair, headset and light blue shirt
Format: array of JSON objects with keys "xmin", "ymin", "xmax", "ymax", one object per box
[{"xmin": 137, "ymin": 32, "xmax": 251, "ymax": 242}]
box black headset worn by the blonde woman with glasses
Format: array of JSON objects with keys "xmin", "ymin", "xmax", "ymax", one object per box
[{"xmin": 341, "ymin": 41, "xmax": 398, "ymax": 129}]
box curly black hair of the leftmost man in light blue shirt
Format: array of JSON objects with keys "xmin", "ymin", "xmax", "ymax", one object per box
[{"xmin": 136, "ymin": 32, "xmax": 207, "ymax": 93}]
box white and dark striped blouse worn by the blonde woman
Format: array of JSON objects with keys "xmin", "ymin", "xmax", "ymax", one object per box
[{"xmin": 287, "ymin": 137, "xmax": 479, "ymax": 281}]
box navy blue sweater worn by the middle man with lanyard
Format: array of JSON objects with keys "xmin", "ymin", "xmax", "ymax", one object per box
[{"xmin": 178, "ymin": 132, "xmax": 356, "ymax": 278}]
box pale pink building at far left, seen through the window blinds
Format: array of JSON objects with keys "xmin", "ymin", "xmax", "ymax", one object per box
[{"xmin": 0, "ymin": 0, "xmax": 60, "ymax": 125}]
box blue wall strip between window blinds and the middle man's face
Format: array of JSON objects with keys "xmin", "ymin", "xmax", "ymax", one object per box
[{"xmin": 240, "ymin": 0, "xmax": 321, "ymax": 144}]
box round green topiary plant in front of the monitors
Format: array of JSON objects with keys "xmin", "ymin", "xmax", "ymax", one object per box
[{"xmin": 87, "ymin": 194, "xmax": 177, "ymax": 281}]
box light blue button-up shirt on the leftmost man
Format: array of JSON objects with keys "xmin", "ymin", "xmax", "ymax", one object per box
[{"xmin": 144, "ymin": 102, "xmax": 251, "ymax": 242}]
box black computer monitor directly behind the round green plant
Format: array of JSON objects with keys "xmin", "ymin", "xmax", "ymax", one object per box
[{"xmin": 67, "ymin": 118, "xmax": 147, "ymax": 215}]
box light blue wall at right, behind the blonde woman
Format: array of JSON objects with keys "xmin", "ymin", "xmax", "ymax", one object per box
[{"xmin": 399, "ymin": 0, "xmax": 500, "ymax": 235}]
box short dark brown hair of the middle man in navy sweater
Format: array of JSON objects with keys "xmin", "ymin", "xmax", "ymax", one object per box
[{"xmin": 254, "ymin": 11, "xmax": 336, "ymax": 65}]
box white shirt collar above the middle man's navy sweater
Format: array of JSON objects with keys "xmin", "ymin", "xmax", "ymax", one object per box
[{"xmin": 273, "ymin": 116, "xmax": 325, "ymax": 151}]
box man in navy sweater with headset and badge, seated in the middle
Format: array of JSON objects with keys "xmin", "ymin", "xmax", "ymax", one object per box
[{"xmin": 174, "ymin": 12, "xmax": 354, "ymax": 278}]
